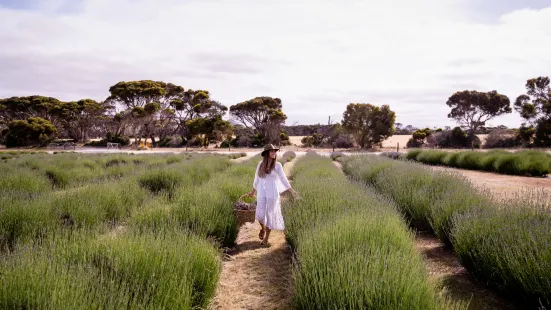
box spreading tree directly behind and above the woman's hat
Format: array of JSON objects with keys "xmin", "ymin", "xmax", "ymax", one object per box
[{"xmin": 230, "ymin": 97, "xmax": 287, "ymax": 143}]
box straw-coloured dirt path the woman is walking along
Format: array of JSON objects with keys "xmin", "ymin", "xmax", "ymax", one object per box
[{"xmin": 209, "ymin": 158, "xmax": 297, "ymax": 310}]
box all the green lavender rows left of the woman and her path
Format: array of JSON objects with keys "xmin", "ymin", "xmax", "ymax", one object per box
[{"xmin": 0, "ymin": 154, "xmax": 242, "ymax": 309}]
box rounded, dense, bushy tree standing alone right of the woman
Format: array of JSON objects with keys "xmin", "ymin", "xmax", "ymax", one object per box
[{"xmin": 342, "ymin": 103, "xmax": 396, "ymax": 148}]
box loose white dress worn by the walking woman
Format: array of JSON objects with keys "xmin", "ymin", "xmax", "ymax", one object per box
[{"xmin": 253, "ymin": 162, "xmax": 291, "ymax": 230}]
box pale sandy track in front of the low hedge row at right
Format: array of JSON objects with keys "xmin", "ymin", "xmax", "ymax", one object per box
[{"xmin": 431, "ymin": 166, "xmax": 551, "ymax": 198}]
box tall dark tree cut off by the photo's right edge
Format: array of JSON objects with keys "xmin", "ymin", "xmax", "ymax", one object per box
[{"xmin": 515, "ymin": 76, "xmax": 551, "ymax": 146}]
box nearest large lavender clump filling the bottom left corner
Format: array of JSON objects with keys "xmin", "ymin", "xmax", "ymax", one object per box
[{"xmin": 0, "ymin": 229, "xmax": 221, "ymax": 309}]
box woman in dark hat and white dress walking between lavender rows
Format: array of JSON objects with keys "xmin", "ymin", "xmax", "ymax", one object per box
[{"xmin": 249, "ymin": 144, "xmax": 295, "ymax": 245}]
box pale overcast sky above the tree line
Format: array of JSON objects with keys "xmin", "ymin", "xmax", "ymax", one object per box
[{"xmin": 0, "ymin": 0, "xmax": 551, "ymax": 127}]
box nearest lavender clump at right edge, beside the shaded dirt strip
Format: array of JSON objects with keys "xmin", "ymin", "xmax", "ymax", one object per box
[{"xmin": 451, "ymin": 192, "xmax": 551, "ymax": 308}]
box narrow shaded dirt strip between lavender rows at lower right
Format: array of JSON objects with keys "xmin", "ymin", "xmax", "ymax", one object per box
[{"xmin": 415, "ymin": 232, "xmax": 520, "ymax": 310}]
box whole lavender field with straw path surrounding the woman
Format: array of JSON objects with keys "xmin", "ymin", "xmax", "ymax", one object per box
[{"xmin": 0, "ymin": 153, "xmax": 551, "ymax": 309}]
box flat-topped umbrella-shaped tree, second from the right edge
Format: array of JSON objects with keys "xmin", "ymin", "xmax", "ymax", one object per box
[{"xmin": 446, "ymin": 90, "xmax": 512, "ymax": 139}]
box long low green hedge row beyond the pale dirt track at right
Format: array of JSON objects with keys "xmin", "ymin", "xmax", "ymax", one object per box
[{"xmin": 405, "ymin": 149, "xmax": 551, "ymax": 177}]
